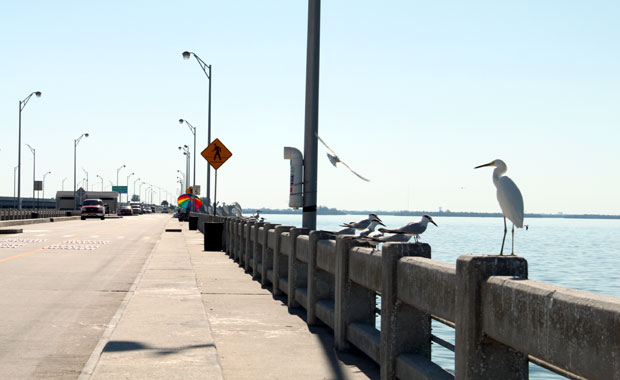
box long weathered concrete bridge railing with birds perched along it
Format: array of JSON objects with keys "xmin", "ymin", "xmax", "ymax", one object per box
[{"xmin": 195, "ymin": 214, "xmax": 620, "ymax": 379}]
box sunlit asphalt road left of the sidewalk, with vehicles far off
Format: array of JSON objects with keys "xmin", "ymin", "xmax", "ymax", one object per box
[{"xmin": 0, "ymin": 214, "xmax": 170, "ymax": 379}]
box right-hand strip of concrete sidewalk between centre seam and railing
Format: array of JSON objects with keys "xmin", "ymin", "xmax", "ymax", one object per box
[{"xmin": 183, "ymin": 224, "xmax": 379, "ymax": 380}]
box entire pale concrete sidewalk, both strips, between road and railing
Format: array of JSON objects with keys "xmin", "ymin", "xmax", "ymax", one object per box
[{"xmin": 80, "ymin": 219, "xmax": 379, "ymax": 380}]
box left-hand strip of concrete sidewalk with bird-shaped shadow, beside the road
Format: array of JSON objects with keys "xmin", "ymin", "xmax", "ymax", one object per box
[{"xmin": 80, "ymin": 219, "xmax": 223, "ymax": 380}]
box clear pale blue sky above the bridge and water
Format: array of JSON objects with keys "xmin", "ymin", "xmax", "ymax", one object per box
[{"xmin": 0, "ymin": 0, "xmax": 620, "ymax": 214}]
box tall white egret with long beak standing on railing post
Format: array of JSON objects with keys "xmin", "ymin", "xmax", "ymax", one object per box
[{"xmin": 474, "ymin": 160, "xmax": 523, "ymax": 255}]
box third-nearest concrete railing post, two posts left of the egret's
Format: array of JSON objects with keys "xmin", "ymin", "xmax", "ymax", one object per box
[{"xmin": 334, "ymin": 236, "xmax": 368, "ymax": 350}]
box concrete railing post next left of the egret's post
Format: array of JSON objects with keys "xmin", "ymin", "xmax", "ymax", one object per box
[{"xmin": 379, "ymin": 243, "xmax": 431, "ymax": 380}]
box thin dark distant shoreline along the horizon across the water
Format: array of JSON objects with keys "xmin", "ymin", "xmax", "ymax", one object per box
[{"xmin": 243, "ymin": 207, "xmax": 620, "ymax": 219}]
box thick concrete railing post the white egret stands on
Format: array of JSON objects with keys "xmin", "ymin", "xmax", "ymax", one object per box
[{"xmin": 454, "ymin": 255, "xmax": 529, "ymax": 380}]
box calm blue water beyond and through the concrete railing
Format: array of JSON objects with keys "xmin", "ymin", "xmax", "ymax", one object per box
[{"xmin": 262, "ymin": 214, "xmax": 620, "ymax": 380}]
